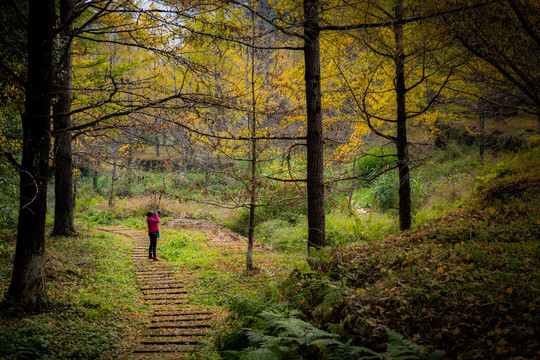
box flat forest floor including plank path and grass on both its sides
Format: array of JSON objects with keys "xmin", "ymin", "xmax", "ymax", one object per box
[{"xmin": 0, "ymin": 218, "xmax": 289, "ymax": 359}]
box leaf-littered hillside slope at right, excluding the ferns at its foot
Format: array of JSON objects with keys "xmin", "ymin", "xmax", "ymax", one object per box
[{"xmin": 285, "ymin": 148, "xmax": 540, "ymax": 359}]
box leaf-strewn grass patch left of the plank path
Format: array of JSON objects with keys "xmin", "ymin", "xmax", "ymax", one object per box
[{"xmin": 0, "ymin": 232, "xmax": 149, "ymax": 360}]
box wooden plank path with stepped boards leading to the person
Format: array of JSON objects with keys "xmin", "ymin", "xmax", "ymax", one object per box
[{"xmin": 100, "ymin": 227, "xmax": 216, "ymax": 360}]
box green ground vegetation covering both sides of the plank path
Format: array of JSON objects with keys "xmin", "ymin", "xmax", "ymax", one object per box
[{"xmin": 0, "ymin": 120, "xmax": 540, "ymax": 359}]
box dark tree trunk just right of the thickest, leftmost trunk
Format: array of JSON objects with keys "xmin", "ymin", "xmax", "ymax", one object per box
[{"xmin": 52, "ymin": 0, "xmax": 75, "ymax": 236}]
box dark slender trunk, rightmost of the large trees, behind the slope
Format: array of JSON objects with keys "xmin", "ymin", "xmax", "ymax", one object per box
[{"xmin": 394, "ymin": 0, "xmax": 411, "ymax": 230}]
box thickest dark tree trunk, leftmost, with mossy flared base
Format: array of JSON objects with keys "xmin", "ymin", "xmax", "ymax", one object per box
[{"xmin": 6, "ymin": 0, "xmax": 55, "ymax": 309}]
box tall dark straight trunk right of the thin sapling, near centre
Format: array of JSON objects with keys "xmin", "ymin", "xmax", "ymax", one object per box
[{"xmin": 304, "ymin": 0, "xmax": 326, "ymax": 253}]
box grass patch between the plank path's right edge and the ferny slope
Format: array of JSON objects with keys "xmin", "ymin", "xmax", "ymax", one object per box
[{"xmin": 158, "ymin": 228, "xmax": 302, "ymax": 307}]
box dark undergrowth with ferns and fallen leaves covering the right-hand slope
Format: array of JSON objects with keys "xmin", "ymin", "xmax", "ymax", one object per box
[{"xmin": 207, "ymin": 147, "xmax": 540, "ymax": 359}]
